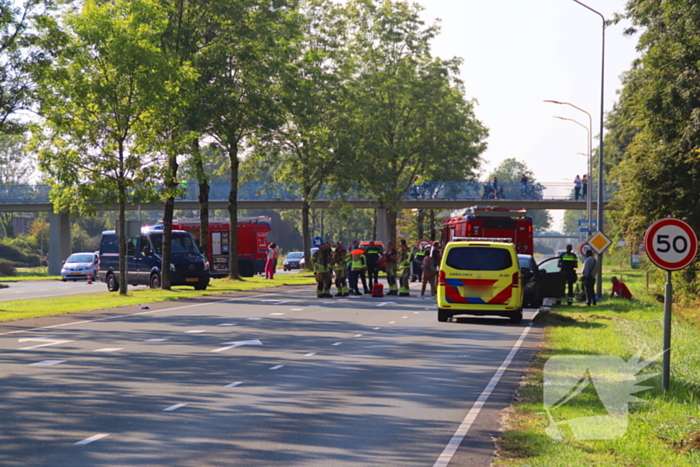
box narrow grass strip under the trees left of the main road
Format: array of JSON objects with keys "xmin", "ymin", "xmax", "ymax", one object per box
[{"xmin": 0, "ymin": 272, "xmax": 316, "ymax": 322}]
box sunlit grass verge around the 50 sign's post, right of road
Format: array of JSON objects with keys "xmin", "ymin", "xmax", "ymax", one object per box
[{"xmin": 494, "ymin": 271, "xmax": 700, "ymax": 467}]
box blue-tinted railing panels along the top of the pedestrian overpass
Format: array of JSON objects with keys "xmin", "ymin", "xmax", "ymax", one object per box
[{"xmin": 0, "ymin": 182, "xmax": 618, "ymax": 204}]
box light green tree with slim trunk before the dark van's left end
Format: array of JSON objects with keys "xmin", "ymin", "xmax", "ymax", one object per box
[{"xmin": 34, "ymin": 0, "xmax": 171, "ymax": 294}]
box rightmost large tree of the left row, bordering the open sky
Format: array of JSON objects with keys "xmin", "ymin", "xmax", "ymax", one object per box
[{"xmin": 348, "ymin": 0, "xmax": 487, "ymax": 239}]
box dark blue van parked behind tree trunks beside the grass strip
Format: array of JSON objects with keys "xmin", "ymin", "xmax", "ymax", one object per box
[{"xmin": 97, "ymin": 226, "xmax": 209, "ymax": 292}]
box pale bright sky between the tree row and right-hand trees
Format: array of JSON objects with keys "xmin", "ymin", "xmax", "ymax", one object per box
[{"xmin": 416, "ymin": 0, "xmax": 638, "ymax": 229}]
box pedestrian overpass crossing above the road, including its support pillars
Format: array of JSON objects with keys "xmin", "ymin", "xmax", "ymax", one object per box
[{"xmin": 0, "ymin": 182, "xmax": 617, "ymax": 275}]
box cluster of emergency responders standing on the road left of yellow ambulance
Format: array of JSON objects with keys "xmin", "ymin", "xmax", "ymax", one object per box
[{"xmin": 311, "ymin": 239, "xmax": 432, "ymax": 298}]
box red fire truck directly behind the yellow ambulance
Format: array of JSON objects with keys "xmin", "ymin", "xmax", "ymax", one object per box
[{"xmin": 442, "ymin": 206, "xmax": 535, "ymax": 255}]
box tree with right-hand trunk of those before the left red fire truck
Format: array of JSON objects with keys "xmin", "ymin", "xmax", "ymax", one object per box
[{"xmin": 197, "ymin": 0, "xmax": 297, "ymax": 279}]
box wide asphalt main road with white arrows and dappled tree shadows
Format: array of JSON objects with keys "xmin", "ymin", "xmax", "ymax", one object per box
[{"xmin": 0, "ymin": 287, "xmax": 541, "ymax": 467}]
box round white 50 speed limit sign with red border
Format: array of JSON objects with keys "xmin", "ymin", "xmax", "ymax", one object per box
[{"xmin": 644, "ymin": 217, "xmax": 698, "ymax": 271}]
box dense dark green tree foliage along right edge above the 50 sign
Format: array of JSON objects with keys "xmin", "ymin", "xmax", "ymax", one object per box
[{"xmin": 609, "ymin": 0, "xmax": 700, "ymax": 296}]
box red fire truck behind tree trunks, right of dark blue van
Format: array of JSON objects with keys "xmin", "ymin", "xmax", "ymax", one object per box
[{"xmin": 173, "ymin": 216, "xmax": 272, "ymax": 277}]
